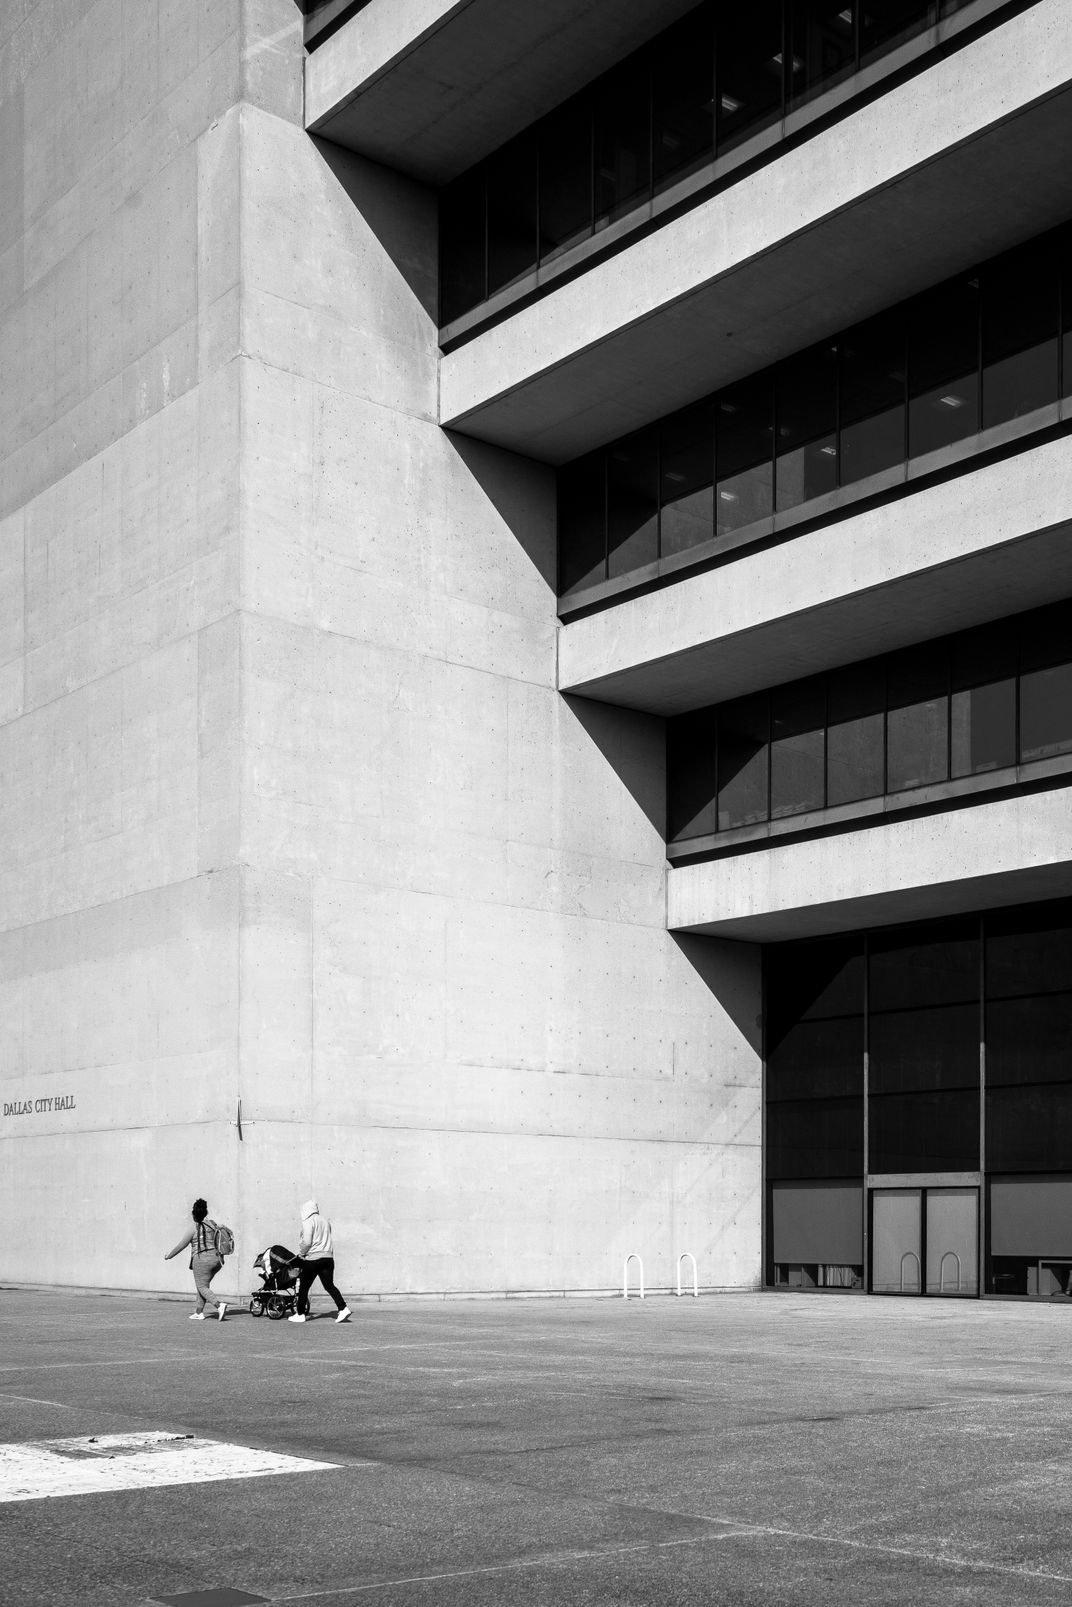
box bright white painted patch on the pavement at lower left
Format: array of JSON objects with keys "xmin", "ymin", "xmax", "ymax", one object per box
[{"xmin": 0, "ymin": 1430, "xmax": 343, "ymax": 1503}]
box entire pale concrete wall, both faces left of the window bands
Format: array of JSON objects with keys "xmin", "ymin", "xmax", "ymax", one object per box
[{"xmin": 0, "ymin": 0, "xmax": 760, "ymax": 1294}]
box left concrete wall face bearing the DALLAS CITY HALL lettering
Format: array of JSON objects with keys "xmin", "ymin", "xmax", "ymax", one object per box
[{"xmin": 0, "ymin": 0, "xmax": 263, "ymax": 1287}]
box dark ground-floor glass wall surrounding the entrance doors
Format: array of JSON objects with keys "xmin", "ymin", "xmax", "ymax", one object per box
[{"xmin": 763, "ymin": 898, "xmax": 1072, "ymax": 1298}]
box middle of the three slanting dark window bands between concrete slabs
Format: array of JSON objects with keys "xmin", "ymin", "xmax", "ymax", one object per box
[{"xmin": 559, "ymin": 227, "xmax": 1072, "ymax": 595}]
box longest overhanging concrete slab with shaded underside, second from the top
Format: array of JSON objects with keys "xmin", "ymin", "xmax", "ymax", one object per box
[{"xmin": 440, "ymin": 0, "xmax": 1072, "ymax": 463}]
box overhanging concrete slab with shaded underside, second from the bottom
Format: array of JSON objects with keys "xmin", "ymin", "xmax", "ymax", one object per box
[{"xmin": 559, "ymin": 437, "xmax": 1072, "ymax": 715}]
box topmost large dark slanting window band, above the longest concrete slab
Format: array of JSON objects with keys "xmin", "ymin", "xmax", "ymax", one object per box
[{"xmin": 440, "ymin": 0, "xmax": 959, "ymax": 323}]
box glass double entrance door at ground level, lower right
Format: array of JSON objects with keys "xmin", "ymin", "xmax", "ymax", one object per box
[{"xmin": 871, "ymin": 1188, "xmax": 979, "ymax": 1298}]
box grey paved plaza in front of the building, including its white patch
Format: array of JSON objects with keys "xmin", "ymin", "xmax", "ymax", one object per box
[{"xmin": 0, "ymin": 1290, "xmax": 1072, "ymax": 1607}]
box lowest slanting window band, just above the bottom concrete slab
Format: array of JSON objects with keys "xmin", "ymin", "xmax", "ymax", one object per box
[{"xmin": 667, "ymin": 601, "xmax": 1072, "ymax": 844}]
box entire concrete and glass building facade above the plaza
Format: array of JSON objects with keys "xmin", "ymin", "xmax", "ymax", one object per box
[{"xmin": 0, "ymin": 0, "xmax": 1072, "ymax": 1295}]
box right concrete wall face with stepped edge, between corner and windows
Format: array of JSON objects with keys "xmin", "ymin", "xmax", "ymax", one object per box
[{"xmin": 226, "ymin": 6, "xmax": 760, "ymax": 1292}]
